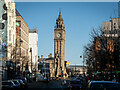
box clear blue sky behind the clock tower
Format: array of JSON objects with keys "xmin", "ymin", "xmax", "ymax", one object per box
[{"xmin": 16, "ymin": 2, "xmax": 118, "ymax": 65}]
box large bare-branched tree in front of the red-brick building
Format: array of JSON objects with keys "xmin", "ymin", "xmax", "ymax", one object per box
[{"xmin": 84, "ymin": 27, "xmax": 119, "ymax": 75}]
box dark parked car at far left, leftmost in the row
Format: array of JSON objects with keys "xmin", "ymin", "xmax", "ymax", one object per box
[{"xmin": 2, "ymin": 81, "xmax": 17, "ymax": 90}]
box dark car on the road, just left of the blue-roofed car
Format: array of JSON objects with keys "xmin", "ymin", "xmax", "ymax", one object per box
[{"xmin": 68, "ymin": 80, "xmax": 83, "ymax": 90}]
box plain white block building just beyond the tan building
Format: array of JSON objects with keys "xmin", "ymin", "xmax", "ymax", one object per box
[{"xmin": 29, "ymin": 29, "xmax": 38, "ymax": 72}]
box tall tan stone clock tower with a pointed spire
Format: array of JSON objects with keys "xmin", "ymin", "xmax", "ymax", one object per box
[{"xmin": 54, "ymin": 12, "xmax": 66, "ymax": 77}]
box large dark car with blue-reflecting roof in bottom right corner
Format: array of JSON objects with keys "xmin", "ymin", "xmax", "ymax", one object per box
[{"xmin": 88, "ymin": 81, "xmax": 120, "ymax": 90}]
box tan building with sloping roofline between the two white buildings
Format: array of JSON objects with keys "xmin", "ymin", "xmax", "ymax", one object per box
[{"xmin": 16, "ymin": 10, "xmax": 29, "ymax": 72}]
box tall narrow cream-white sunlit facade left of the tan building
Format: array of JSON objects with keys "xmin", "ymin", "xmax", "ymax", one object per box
[{"xmin": 5, "ymin": 0, "xmax": 16, "ymax": 60}]
